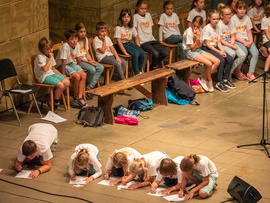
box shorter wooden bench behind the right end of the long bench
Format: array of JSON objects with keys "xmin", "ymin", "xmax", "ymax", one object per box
[{"xmin": 165, "ymin": 59, "xmax": 199, "ymax": 84}]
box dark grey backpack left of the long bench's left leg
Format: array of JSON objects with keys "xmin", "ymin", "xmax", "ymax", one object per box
[{"xmin": 76, "ymin": 106, "xmax": 104, "ymax": 127}]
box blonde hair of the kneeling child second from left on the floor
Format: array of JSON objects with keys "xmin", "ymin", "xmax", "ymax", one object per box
[{"xmin": 73, "ymin": 148, "xmax": 90, "ymax": 173}]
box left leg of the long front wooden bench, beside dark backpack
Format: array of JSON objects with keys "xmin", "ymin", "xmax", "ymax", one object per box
[{"xmin": 98, "ymin": 94, "xmax": 114, "ymax": 124}]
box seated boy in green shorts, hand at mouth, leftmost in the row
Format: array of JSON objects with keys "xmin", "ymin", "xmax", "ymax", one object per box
[{"xmin": 34, "ymin": 37, "xmax": 70, "ymax": 111}]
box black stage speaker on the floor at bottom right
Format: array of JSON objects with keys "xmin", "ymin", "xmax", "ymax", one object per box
[{"xmin": 227, "ymin": 176, "xmax": 262, "ymax": 203}]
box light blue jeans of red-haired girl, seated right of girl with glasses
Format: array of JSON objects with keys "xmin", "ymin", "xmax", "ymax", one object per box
[{"xmin": 235, "ymin": 41, "xmax": 259, "ymax": 73}]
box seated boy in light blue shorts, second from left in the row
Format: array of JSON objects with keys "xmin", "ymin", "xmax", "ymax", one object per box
[{"xmin": 56, "ymin": 30, "xmax": 88, "ymax": 107}]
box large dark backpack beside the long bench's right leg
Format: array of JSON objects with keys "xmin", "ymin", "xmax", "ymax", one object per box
[{"xmin": 167, "ymin": 75, "xmax": 196, "ymax": 103}]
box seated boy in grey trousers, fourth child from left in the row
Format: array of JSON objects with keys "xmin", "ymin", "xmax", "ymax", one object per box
[{"xmin": 93, "ymin": 22, "xmax": 127, "ymax": 80}]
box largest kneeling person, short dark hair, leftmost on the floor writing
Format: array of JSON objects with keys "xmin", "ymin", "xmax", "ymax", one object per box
[{"xmin": 14, "ymin": 123, "xmax": 58, "ymax": 178}]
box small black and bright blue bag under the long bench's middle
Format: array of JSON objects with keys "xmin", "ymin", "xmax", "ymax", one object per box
[{"xmin": 128, "ymin": 98, "xmax": 153, "ymax": 111}]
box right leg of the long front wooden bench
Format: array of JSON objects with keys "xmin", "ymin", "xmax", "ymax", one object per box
[{"xmin": 152, "ymin": 77, "xmax": 168, "ymax": 105}]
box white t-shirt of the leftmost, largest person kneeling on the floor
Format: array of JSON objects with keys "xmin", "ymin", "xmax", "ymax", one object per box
[{"xmin": 17, "ymin": 123, "xmax": 58, "ymax": 162}]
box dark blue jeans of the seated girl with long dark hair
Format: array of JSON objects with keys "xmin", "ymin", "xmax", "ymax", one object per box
[{"xmin": 114, "ymin": 42, "xmax": 144, "ymax": 75}]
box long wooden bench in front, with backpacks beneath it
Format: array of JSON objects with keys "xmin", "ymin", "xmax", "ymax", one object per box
[{"xmin": 87, "ymin": 68, "xmax": 174, "ymax": 124}]
